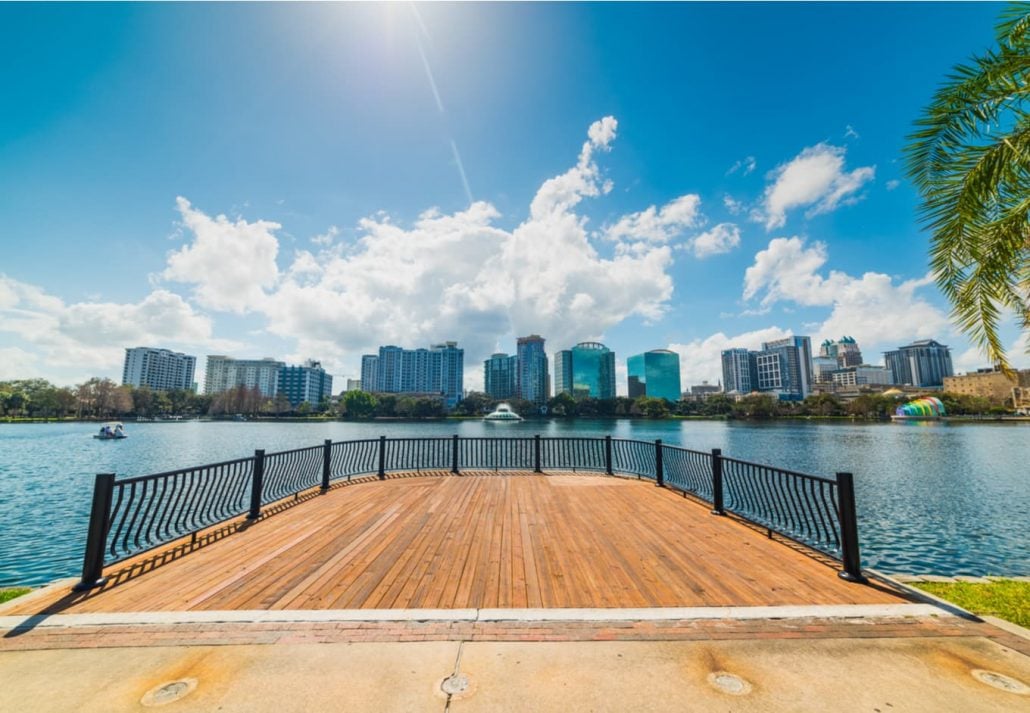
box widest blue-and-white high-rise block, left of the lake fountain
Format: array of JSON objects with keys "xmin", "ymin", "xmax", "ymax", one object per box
[{"xmin": 362, "ymin": 342, "xmax": 465, "ymax": 408}]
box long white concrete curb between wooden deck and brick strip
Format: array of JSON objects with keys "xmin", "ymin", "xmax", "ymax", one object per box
[{"xmin": 0, "ymin": 604, "xmax": 946, "ymax": 630}]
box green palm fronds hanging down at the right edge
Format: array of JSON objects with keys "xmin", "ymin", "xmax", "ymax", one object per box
[{"xmin": 905, "ymin": 3, "xmax": 1030, "ymax": 372}]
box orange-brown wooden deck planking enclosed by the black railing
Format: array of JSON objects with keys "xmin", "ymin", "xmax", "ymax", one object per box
[{"xmin": 12, "ymin": 473, "xmax": 900, "ymax": 613}]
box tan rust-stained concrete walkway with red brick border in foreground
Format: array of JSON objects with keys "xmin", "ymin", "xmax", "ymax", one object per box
[{"xmin": 0, "ymin": 609, "xmax": 1030, "ymax": 713}]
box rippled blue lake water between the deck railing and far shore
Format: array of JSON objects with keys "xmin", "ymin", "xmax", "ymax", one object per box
[{"xmin": 0, "ymin": 420, "xmax": 1030, "ymax": 586}]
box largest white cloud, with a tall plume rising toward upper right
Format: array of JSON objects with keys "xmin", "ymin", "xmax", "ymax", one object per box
[{"xmin": 166, "ymin": 117, "xmax": 675, "ymax": 387}]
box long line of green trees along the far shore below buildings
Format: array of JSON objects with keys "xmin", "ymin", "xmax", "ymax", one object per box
[{"xmin": 0, "ymin": 378, "xmax": 1011, "ymax": 422}]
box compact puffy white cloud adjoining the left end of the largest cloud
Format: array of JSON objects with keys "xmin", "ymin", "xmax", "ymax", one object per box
[{"xmin": 161, "ymin": 197, "xmax": 281, "ymax": 314}]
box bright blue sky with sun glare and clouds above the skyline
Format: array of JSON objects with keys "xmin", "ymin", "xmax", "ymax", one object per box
[{"xmin": 0, "ymin": 3, "xmax": 1026, "ymax": 391}]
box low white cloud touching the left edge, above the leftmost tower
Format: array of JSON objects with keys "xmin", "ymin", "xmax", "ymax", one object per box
[{"xmin": 0, "ymin": 275, "xmax": 234, "ymax": 381}]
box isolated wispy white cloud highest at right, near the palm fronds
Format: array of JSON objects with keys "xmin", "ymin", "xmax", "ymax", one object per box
[{"xmin": 753, "ymin": 143, "xmax": 876, "ymax": 230}]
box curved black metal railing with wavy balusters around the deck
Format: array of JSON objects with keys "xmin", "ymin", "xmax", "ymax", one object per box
[{"xmin": 70, "ymin": 436, "xmax": 864, "ymax": 589}]
